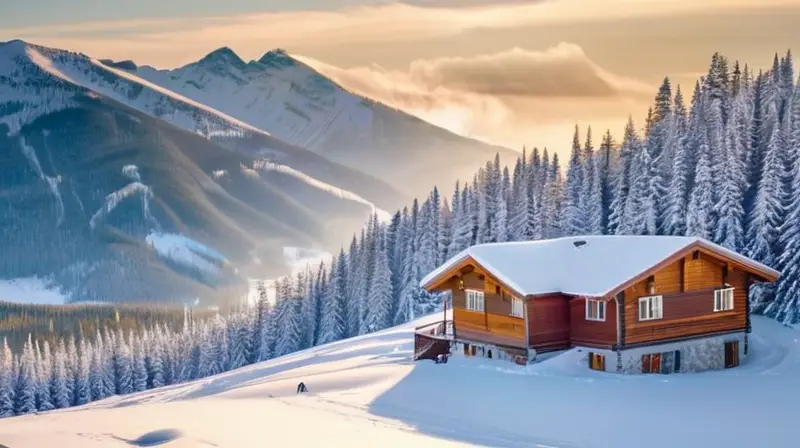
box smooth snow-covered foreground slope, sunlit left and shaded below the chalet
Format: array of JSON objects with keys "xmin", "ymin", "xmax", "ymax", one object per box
[{"xmin": 0, "ymin": 316, "xmax": 800, "ymax": 448}]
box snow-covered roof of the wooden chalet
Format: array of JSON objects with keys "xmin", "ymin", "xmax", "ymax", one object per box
[{"xmin": 420, "ymin": 235, "xmax": 778, "ymax": 297}]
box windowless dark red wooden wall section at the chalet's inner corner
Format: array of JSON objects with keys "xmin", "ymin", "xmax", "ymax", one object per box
[{"xmin": 525, "ymin": 295, "xmax": 570, "ymax": 351}]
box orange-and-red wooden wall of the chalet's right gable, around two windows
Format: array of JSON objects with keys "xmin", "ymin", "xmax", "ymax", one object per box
[{"xmin": 624, "ymin": 253, "xmax": 748, "ymax": 345}]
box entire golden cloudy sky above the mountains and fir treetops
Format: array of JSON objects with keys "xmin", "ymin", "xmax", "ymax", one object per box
[{"xmin": 0, "ymin": 0, "xmax": 800, "ymax": 155}]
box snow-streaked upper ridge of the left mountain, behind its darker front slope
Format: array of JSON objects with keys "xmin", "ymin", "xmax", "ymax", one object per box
[{"xmin": 0, "ymin": 41, "xmax": 401, "ymax": 208}]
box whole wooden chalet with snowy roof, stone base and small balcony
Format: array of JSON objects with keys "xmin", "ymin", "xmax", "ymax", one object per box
[{"xmin": 415, "ymin": 236, "xmax": 778, "ymax": 373}]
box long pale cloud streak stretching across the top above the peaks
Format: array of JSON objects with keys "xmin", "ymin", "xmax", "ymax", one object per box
[{"xmin": 0, "ymin": 0, "xmax": 796, "ymax": 66}]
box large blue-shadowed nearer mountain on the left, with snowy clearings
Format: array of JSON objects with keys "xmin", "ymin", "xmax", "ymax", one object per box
[{"xmin": 0, "ymin": 41, "xmax": 399, "ymax": 302}]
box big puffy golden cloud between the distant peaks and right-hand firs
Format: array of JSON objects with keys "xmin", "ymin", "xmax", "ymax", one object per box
[{"xmin": 296, "ymin": 43, "xmax": 655, "ymax": 152}]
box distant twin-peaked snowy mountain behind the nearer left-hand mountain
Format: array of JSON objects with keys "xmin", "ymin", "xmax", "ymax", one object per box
[{"xmin": 122, "ymin": 48, "xmax": 518, "ymax": 199}]
